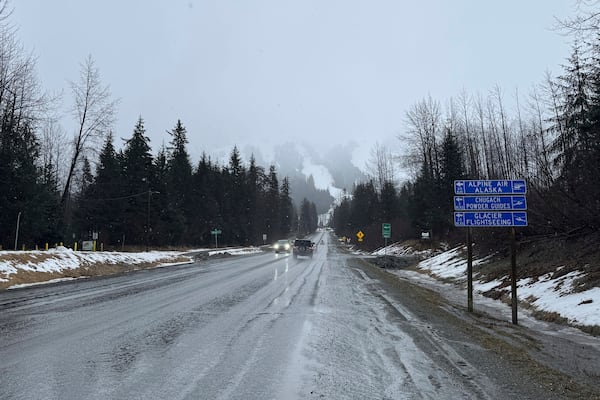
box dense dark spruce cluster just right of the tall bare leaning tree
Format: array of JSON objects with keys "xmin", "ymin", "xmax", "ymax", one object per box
[{"xmin": 71, "ymin": 118, "xmax": 308, "ymax": 250}]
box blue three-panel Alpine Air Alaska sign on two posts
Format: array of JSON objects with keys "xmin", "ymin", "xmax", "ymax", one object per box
[{"xmin": 454, "ymin": 179, "xmax": 527, "ymax": 325}]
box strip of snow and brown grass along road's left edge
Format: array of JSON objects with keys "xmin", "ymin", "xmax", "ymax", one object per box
[{"xmin": 0, "ymin": 246, "xmax": 261, "ymax": 288}]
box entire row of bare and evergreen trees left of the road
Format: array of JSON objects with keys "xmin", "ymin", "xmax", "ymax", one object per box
[{"xmin": 0, "ymin": 4, "xmax": 317, "ymax": 249}]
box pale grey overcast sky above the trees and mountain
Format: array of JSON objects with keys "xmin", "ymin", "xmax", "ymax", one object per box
[{"xmin": 11, "ymin": 0, "xmax": 574, "ymax": 166}]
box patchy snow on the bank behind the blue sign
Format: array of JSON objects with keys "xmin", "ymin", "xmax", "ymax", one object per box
[{"xmin": 373, "ymin": 244, "xmax": 600, "ymax": 326}]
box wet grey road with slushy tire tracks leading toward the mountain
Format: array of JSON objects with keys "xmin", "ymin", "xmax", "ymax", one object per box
[{"xmin": 0, "ymin": 235, "xmax": 600, "ymax": 399}]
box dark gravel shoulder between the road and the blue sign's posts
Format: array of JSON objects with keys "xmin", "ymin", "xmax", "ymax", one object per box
[{"xmin": 349, "ymin": 258, "xmax": 600, "ymax": 398}]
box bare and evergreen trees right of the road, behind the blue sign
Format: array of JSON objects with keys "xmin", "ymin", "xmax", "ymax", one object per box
[{"xmin": 333, "ymin": 6, "xmax": 600, "ymax": 247}]
